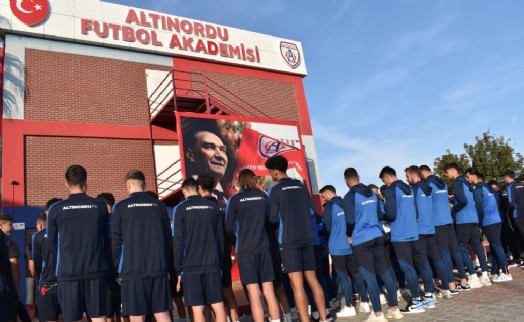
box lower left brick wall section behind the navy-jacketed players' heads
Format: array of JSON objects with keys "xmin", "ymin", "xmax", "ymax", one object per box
[{"xmin": 25, "ymin": 136, "xmax": 156, "ymax": 206}]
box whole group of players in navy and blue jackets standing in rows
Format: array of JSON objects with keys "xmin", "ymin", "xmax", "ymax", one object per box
[{"xmin": 0, "ymin": 155, "xmax": 524, "ymax": 322}]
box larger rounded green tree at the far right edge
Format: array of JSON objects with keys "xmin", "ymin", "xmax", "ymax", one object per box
[{"xmin": 464, "ymin": 130, "xmax": 524, "ymax": 181}]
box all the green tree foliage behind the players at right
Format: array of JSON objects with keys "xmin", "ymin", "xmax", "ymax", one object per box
[{"xmin": 434, "ymin": 130, "xmax": 524, "ymax": 181}]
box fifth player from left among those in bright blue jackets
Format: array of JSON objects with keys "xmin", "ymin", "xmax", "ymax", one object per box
[{"xmin": 420, "ymin": 165, "xmax": 471, "ymax": 294}]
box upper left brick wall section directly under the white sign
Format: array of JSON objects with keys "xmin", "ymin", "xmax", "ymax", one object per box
[{"xmin": 24, "ymin": 49, "xmax": 169, "ymax": 125}]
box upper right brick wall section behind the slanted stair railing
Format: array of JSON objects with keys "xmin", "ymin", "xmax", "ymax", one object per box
[{"xmin": 194, "ymin": 70, "xmax": 300, "ymax": 122}]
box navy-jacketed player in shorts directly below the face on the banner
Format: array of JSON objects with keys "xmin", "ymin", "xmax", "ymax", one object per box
[{"xmin": 172, "ymin": 178, "xmax": 226, "ymax": 322}]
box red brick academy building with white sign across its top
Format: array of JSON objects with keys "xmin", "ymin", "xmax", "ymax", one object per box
[{"xmin": 0, "ymin": 0, "xmax": 319, "ymax": 208}]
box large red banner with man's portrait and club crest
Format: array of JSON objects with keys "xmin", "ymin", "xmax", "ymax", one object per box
[{"xmin": 177, "ymin": 113, "xmax": 310, "ymax": 205}]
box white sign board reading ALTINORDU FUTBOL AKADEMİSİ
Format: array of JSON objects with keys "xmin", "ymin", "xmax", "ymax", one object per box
[{"xmin": 0, "ymin": 0, "xmax": 307, "ymax": 75}]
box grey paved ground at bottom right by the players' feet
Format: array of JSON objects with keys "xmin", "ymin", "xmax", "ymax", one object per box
[{"xmin": 25, "ymin": 268, "xmax": 524, "ymax": 322}]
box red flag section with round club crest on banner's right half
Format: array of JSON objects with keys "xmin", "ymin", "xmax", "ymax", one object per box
[{"xmin": 235, "ymin": 126, "xmax": 309, "ymax": 187}]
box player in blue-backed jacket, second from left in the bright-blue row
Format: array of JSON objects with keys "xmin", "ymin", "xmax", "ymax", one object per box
[{"xmin": 344, "ymin": 168, "xmax": 404, "ymax": 322}]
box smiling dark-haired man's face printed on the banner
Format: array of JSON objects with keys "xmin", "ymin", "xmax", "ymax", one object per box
[{"xmin": 186, "ymin": 131, "xmax": 228, "ymax": 180}]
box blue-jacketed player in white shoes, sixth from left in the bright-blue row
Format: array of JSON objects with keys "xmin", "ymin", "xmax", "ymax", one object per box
[{"xmin": 444, "ymin": 162, "xmax": 491, "ymax": 288}]
